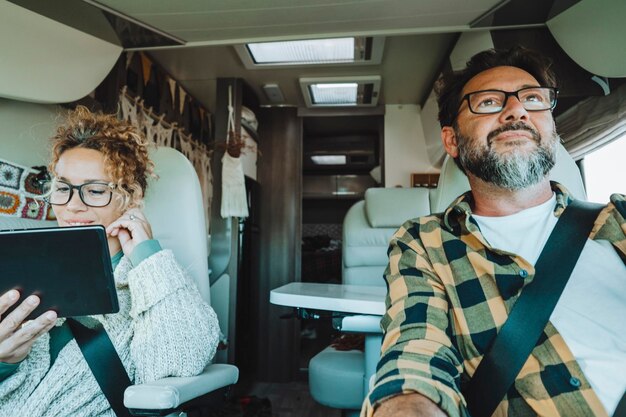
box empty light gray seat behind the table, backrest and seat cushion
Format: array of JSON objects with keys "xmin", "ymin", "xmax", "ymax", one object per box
[{"xmin": 309, "ymin": 188, "xmax": 430, "ymax": 415}]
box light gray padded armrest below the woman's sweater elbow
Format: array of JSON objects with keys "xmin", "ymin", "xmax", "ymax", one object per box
[{"xmin": 124, "ymin": 364, "xmax": 239, "ymax": 410}]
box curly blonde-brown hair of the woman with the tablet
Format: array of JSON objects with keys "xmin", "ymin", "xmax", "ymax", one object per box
[{"xmin": 49, "ymin": 106, "xmax": 156, "ymax": 211}]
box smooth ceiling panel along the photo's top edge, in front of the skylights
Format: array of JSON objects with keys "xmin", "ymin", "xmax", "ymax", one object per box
[{"xmin": 94, "ymin": 0, "xmax": 502, "ymax": 43}]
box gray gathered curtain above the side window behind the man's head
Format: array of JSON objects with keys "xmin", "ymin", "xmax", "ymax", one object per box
[{"xmin": 556, "ymin": 84, "xmax": 626, "ymax": 160}]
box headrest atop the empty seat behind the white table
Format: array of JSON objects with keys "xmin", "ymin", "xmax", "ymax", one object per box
[{"xmin": 365, "ymin": 187, "xmax": 430, "ymax": 227}]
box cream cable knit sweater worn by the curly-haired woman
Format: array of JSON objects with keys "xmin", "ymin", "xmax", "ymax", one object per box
[{"xmin": 0, "ymin": 250, "xmax": 219, "ymax": 417}]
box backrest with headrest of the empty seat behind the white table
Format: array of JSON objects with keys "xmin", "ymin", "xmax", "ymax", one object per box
[{"xmin": 342, "ymin": 188, "xmax": 430, "ymax": 286}]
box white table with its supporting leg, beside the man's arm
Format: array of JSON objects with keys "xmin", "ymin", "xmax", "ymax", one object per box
[{"xmin": 270, "ymin": 282, "xmax": 387, "ymax": 395}]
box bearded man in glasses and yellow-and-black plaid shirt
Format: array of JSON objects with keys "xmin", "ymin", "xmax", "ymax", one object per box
[{"xmin": 362, "ymin": 47, "xmax": 626, "ymax": 417}]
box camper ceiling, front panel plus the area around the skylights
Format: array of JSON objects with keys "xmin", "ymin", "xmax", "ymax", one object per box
[{"xmin": 86, "ymin": 0, "xmax": 503, "ymax": 109}]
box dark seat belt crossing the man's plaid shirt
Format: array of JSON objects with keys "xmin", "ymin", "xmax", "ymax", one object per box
[{"xmin": 463, "ymin": 200, "xmax": 604, "ymax": 417}]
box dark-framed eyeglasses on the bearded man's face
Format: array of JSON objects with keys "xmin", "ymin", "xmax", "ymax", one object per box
[{"xmin": 461, "ymin": 87, "xmax": 559, "ymax": 114}]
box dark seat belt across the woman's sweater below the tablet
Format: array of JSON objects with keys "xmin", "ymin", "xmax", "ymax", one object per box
[{"xmin": 66, "ymin": 318, "xmax": 131, "ymax": 417}]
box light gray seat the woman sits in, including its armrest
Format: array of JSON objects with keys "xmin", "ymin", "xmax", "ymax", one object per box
[{"xmin": 124, "ymin": 148, "xmax": 239, "ymax": 415}]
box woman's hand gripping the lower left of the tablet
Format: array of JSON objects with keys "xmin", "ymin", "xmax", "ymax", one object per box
[{"xmin": 0, "ymin": 290, "xmax": 57, "ymax": 363}]
